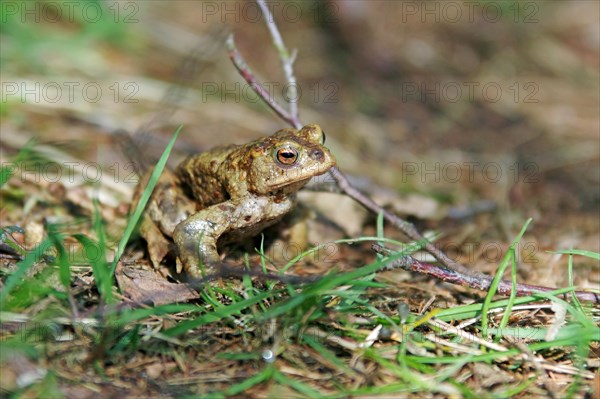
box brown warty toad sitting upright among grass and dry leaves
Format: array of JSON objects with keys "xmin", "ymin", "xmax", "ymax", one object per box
[{"xmin": 134, "ymin": 125, "xmax": 335, "ymax": 278}]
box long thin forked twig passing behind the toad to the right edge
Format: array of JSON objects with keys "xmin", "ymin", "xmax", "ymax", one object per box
[{"xmin": 227, "ymin": 5, "xmax": 600, "ymax": 302}]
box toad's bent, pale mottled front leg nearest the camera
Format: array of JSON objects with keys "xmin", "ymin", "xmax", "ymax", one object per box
[{"xmin": 173, "ymin": 197, "xmax": 278, "ymax": 278}]
